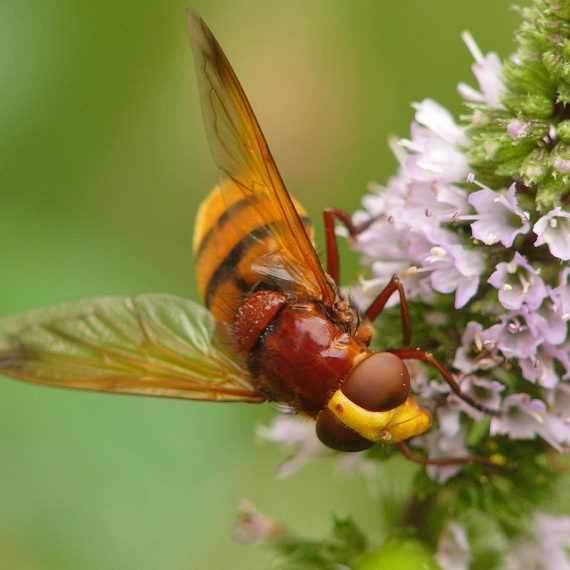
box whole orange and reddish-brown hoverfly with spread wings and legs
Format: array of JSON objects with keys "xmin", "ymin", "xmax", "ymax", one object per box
[{"xmin": 0, "ymin": 12, "xmax": 492, "ymax": 463}]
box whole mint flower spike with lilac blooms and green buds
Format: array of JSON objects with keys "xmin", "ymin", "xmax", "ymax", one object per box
[{"xmin": 254, "ymin": 4, "xmax": 570, "ymax": 570}]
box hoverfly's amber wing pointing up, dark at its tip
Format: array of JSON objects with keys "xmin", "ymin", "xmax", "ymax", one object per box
[{"xmin": 188, "ymin": 11, "xmax": 335, "ymax": 304}]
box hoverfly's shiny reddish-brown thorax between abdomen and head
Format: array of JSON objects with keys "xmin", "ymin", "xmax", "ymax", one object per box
[{"xmin": 234, "ymin": 291, "xmax": 369, "ymax": 416}]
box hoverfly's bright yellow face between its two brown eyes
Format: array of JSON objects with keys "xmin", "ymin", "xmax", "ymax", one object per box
[{"xmin": 328, "ymin": 389, "xmax": 431, "ymax": 443}]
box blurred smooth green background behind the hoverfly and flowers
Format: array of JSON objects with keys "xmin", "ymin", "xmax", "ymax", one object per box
[{"xmin": 0, "ymin": 0, "xmax": 518, "ymax": 570}]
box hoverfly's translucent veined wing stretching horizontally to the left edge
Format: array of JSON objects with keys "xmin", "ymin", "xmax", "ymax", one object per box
[{"xmin": 0, "ymin": 294, "xmax": 264, "ymax": 402}]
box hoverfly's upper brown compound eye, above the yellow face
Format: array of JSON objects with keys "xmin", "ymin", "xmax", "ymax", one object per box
[{"xmin": 341, "ymin": 352, "xmax": 410, "ymax": 412}]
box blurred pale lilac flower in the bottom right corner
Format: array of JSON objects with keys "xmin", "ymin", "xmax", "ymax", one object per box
[{"xmin": 504, "ymin": 512, "xmax": 570, "ymax": 570}]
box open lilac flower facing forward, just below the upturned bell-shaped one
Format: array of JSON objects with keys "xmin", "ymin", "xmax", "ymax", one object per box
[{"xmin": 487, "ymin": 252, "xmax": 547, "ymax": 310}]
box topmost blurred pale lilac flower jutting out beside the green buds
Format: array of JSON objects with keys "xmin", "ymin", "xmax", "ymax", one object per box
[{"xmin": 458, "ymin": 32, "xmax": 504, "ymax": 107}]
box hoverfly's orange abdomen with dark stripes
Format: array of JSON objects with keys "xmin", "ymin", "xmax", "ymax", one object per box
[{"xmin": 194, "ymin": 182, "xmax": 312, "ymax": 324}]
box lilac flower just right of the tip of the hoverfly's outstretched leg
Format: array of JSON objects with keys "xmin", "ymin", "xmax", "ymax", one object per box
[{"xmin": 490, "ymin": 393, "xmax": 546, "ymax": 439}]
